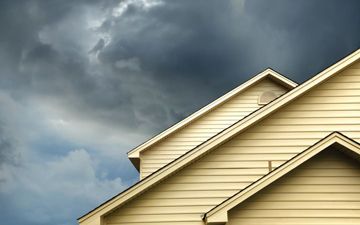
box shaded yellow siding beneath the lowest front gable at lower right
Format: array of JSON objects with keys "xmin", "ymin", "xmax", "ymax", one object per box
[{"xmin": 227, "ymin": 150, "xmax": 360, "ymax": 225}]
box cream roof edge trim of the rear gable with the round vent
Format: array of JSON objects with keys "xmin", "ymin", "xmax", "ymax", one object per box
[{"xmin": 128, "ymin": 68, "xmax": 298, "ymax": 169}]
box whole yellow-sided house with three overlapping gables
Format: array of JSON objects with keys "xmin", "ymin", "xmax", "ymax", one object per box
[{"xmin": 78, "ymin": 50, "xmax": 360, "ymax": 225}]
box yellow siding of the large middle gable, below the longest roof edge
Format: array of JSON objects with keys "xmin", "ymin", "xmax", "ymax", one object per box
[{"xmin": 105, "ymin": 63, "xmax": 360, "ymax": 225}]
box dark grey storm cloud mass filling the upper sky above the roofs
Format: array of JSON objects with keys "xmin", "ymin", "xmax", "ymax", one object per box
[{"xmin": 1, "ymin": 1, "xmax": 360, "ymax": 134}]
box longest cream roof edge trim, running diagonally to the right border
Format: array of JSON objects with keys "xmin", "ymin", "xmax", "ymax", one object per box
[{"xmin": 78, "ymin": 49, "xmax": 360, "ymax": 222}]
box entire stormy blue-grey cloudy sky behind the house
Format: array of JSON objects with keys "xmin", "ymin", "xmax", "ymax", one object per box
[{"xmin": 0, "ymin": 0, "xmax": 360, "ymax": 225}]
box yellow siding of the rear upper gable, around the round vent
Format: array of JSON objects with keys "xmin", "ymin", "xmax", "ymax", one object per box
[{"xmin": 140, "ymin": 78, "xmax": 287, "ymax": 179}]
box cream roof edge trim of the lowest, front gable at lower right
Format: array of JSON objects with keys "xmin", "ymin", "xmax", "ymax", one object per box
[{"xmin": 204, "ymin": 132, "xmax": 360, "ymax": 225}]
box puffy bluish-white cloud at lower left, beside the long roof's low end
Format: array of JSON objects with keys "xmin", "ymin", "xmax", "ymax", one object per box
[{"xmin": 0, "ymin": 149, "xmax": 125, "ymax": 224}]
